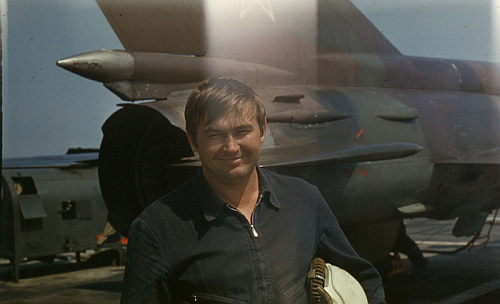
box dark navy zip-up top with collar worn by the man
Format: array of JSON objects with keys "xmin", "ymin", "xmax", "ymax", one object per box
[{"xmin": 122, "ymin": 169, "xmax": 384, "ymax": 304}]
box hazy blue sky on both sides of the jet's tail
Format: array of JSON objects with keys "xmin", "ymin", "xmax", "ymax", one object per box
[{"xmin": 0, "ymin": 0, "xmax": 500, "ymax": 158}]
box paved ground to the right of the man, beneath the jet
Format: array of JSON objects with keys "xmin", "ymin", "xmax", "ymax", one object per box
[{"xmin": 384, "ymin": 217, "xmax": 500, "ymax": 304}]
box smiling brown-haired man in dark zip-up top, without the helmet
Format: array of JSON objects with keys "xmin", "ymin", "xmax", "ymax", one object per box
[{"xmin": 122, "ymin": 77, "xmax": 384, "ymax": 304}]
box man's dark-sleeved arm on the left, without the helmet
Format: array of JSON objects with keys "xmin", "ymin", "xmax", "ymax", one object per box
[{"xmin": 121, "ymin": 218, "xmax": 171, "ymax": 304}]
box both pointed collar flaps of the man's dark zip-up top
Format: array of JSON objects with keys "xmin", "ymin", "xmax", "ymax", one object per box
[{"xmin": 194, "ymin": 168, "xmax": 281, "ymax": 222}]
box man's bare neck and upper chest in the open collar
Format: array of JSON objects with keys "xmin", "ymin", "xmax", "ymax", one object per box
[{"xmin": 205, "ymin": 169, "xmax": 259, "ymax": 221}]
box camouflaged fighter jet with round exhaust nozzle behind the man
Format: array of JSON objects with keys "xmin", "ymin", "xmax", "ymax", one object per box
[{"xmin": 57, "ymin": 0, "xmax": 500, "ymax": 262}]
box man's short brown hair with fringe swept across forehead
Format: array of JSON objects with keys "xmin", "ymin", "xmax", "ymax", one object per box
[{"xmin": 184, "ymin": 76, "xmax": 266, "ymax": 143}]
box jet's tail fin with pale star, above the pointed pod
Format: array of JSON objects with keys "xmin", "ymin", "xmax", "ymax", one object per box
[{"xmin": 97, "ymin": 0, "xmax": 399, "ymax": 58}]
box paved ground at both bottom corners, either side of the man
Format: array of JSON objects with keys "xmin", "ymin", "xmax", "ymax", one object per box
[{"xmin": 0, "ymin": 218, "xmax": 500, "ymax": 304}]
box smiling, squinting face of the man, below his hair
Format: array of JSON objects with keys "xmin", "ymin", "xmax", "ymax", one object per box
[{"xmin": 188, "ymin": 111, "xmax": 265, "ymax": 184}]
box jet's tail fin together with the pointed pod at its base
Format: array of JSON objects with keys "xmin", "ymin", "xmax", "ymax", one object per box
[{"xmin": 58, "ymin": 0, "xmax": 411, "ymax": 101}]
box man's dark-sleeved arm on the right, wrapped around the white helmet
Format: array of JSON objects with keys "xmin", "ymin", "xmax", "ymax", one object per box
[{"xmin": 317, "ymin": 191, "xmax": 385, "ymax": 304}]
